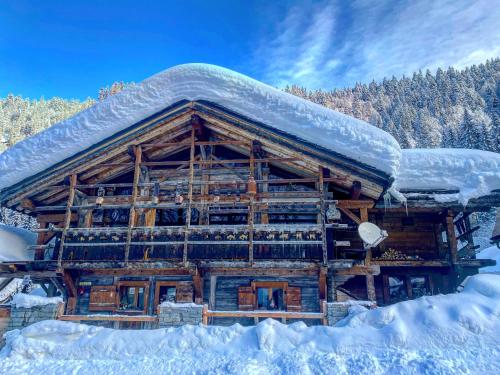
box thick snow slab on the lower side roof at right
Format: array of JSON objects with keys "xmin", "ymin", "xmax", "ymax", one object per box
[{"xmin": 394, "ymin": 148, "xmax": 500, "ymax": 204}]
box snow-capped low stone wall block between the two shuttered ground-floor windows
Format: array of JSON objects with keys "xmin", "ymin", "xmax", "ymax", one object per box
[{"xmin": 158, "ymin": 303, "xmax": 203, "ymax": 328}]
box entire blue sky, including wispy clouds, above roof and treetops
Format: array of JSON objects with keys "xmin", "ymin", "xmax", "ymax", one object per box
[{"xmin": 0, "ymin": 0, "xmax": 500, "ymax": 99}]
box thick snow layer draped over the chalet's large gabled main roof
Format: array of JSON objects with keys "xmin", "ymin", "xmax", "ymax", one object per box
[{"xmin": 0, "ymin": 64, "xmax": 400, "ymax": 189}]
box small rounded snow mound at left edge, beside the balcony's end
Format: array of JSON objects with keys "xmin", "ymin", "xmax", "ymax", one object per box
[{"xmin": 0, "ymin": 224, "xmax": 37, "ymax": 262}]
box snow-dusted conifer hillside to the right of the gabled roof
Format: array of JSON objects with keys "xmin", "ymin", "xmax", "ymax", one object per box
[{"xmin": 285, "ymin": 59, "xmax": 500, "ymax": 152}]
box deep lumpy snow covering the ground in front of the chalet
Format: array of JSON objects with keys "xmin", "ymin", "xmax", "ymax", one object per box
[{"xmin": 0, "ymin": 275, "xmax": 500, "ymax": 375}]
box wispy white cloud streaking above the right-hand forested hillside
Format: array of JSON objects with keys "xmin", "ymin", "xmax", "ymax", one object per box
[{"xmin": 256, "ymin": 0, "xmax": 500, "ymax": 88}]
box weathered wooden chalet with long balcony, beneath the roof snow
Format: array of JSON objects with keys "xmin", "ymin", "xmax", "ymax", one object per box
[{"xmin": 0, "ymin": 66, "xmax": 499, "ymax": 325}]
